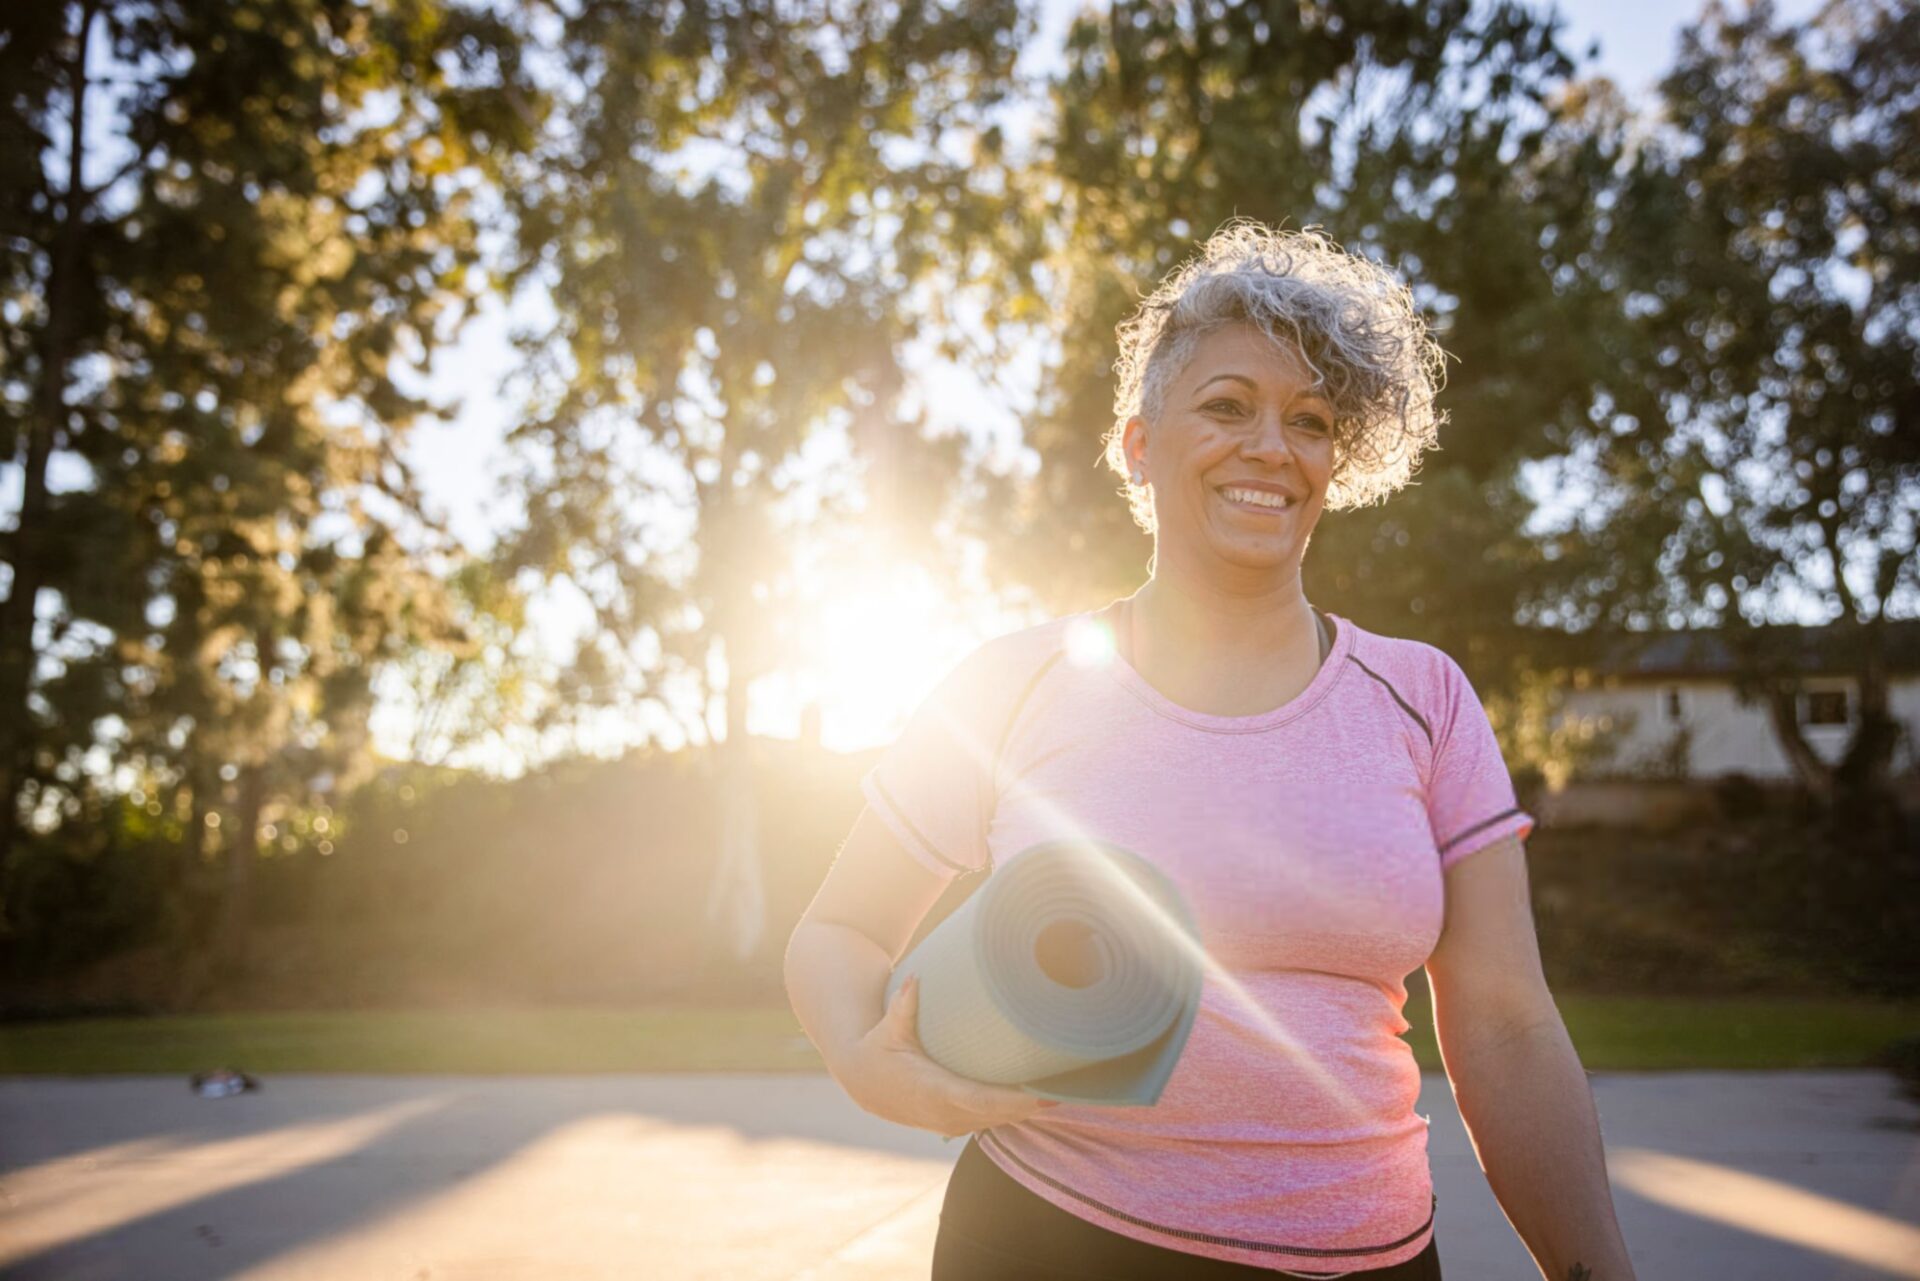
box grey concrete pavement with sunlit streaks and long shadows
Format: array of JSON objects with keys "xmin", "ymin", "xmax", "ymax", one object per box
[{"xmin": 0, "ymin": 1072, "xmax": 1920, "ymax": 1281}]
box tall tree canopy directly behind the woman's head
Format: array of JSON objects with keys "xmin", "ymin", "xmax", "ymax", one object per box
[{"xmin": 960, "ymin": 0, "xmax": 1588, "ymax": 679}]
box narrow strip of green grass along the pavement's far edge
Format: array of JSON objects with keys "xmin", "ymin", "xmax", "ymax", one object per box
[{"xmin": 0, "ymin": 997, "xmax": 1920, "ymax": 1074}]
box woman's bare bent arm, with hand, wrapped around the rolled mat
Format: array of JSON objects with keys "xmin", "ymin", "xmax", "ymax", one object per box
[{"xmin": 785, "ymin": 809, "xmax": 1052, "ymax": 1135}]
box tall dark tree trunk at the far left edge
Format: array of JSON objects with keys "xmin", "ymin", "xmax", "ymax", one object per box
[{"xmin": 0, "ymin": 4, "xmax": 94, "ymax": 887}]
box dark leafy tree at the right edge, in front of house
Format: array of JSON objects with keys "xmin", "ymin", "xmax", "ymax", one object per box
[{"xmin": 1540, "ymin": 0, "xmax": 1920, "ymax": 795}]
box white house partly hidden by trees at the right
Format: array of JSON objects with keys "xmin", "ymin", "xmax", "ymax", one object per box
[{"xmin": 1563, "ymin": 620, "xmax": 1920, "ymax": 782}]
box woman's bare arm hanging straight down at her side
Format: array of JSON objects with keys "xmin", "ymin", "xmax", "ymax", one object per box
[{"xmin": 1427, "ymin": 837, "xmax": 1634, "ymax": 1281}]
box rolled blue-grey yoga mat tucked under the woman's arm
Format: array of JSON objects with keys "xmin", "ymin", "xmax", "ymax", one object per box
[{"xmin": 887, "ymin": 841, "xmax": 1202, "ymax": 1106}]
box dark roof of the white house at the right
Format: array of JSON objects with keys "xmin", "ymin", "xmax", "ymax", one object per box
[{"xmin": 1551, "ymin": 618, "xmax": 1920, "ymax": 680}]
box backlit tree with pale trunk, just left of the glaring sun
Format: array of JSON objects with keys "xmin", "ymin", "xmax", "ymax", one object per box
[{"xmin": 505, "ymin": 0, "xmax": 1025, "ymax": 953}]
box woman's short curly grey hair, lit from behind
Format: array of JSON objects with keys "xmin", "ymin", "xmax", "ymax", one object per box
[{"xmin": 1106, "ymin": 219, "xmax": 1446, "ymax": 532}]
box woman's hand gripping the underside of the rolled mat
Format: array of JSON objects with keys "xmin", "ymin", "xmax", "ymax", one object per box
[{"xmin": 841, "ymin": 974, "xmax": 1054, "ymax": 1137}]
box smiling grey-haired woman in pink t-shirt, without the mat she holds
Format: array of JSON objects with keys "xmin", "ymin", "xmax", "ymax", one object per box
[{"xmin": 787, "ymin": 221, "xmax": 1632, "ymax": 1281}]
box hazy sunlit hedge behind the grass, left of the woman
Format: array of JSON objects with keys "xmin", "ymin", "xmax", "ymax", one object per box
[{"xmin": 0, "ymin": 741, "xmax": 870, "ymax": 1010}]
